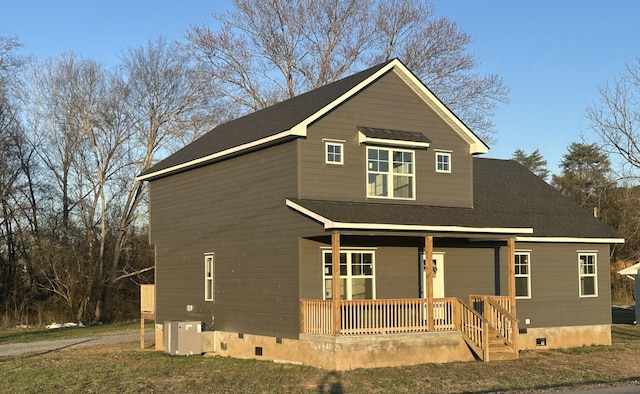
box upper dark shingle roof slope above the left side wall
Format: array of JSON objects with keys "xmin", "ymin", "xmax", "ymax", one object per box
[{"xmin": 141, "ymin": 60, "xmax": 393, "ymax": 175}]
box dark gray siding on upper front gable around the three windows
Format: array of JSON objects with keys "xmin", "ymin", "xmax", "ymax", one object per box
[{"xmin": 299, "ymin": 73, "xmax": 473, "ymax": 207}]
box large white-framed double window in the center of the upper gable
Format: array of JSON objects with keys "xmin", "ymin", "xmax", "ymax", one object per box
[{"xmin": 367, "ymin": 148, "xmax": 415, "ymax": 199}]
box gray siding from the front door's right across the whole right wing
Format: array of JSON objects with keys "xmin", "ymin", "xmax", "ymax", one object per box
[{"xmin": 442, "ymin": 242, "xmax": 611, "ymax": 328}]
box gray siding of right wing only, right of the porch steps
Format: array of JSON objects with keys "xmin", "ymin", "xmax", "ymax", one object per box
[{"xmin": 516, "ymin": 243, "xmax": 611, "ymax": 328}]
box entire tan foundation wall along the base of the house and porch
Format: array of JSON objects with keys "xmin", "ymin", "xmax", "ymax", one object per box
[{"xmin": 156, "ymin": 324, "xmax": 611, "ymax": 371}]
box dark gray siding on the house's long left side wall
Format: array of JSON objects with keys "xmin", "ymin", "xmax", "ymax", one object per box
[{"xmin": 150, "ymin": 142, "xmax": 311, "ymax": 338}]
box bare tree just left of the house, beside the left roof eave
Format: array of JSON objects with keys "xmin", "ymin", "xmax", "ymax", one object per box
[{"xmin": 92, "ymin": 38, "xmax": 218, "ymax": 316}]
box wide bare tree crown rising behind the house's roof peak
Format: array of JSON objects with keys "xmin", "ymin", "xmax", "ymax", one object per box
[{"xmin": 185, "ymin": 0, "xmax": 509, "ymax": 140}]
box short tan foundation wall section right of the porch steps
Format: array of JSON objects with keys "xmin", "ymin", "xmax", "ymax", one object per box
[{"xmin": 518, "ymin": 324, "xmax": 611, "ymax": 350}]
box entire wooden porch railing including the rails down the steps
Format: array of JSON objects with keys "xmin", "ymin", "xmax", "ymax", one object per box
[{"xmin": 301, "ymin": 296, "xmax": 518, "ymax": 360}]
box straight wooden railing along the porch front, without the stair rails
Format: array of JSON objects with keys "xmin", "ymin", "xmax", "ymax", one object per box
[{"xmin": 301, "ymin": 298, "xmax": 459, "ymax": 335}]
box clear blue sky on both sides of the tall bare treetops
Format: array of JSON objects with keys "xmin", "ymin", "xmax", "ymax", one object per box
[{"xmin": 0, "ymin": 0, "xmax": 640, "ymax": 172}]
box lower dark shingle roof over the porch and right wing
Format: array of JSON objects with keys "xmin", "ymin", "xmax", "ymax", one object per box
[{"xmin": 290, "ymin": 158, "xmax": 622, "ymax": 239}]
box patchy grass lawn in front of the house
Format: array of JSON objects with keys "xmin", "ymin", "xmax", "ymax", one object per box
[{"xmin": 0, "ymin": 324, "xmax": 640, "ymax": 393}]
